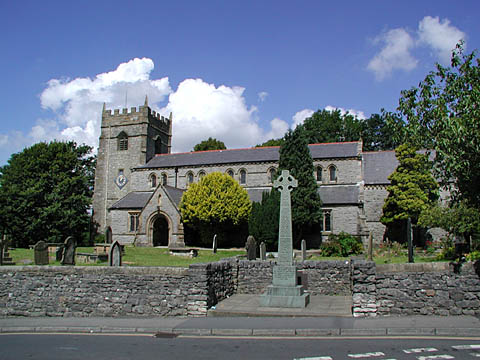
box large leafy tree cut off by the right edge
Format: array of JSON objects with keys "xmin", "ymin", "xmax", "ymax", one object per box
[{"xmin": 398, "ymin": 43, "xmax": 480, "ymax": 209}]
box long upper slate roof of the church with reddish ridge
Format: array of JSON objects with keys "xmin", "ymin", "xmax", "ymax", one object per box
[{"xmin": 137, "ymin": 142, "xmax": 359, "ymax": 169}]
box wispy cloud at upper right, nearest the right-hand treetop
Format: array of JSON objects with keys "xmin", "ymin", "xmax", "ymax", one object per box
[{"xmin": 418, "ymin": 16, "xmax": 466, "ymax": 64}]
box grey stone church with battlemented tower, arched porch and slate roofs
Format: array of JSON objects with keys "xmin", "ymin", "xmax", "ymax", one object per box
[{"xmin": 93, "ymin": 98, "xmax": 398, "ymax": 249}]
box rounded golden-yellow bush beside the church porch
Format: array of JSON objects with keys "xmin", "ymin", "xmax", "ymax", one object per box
[{"xmin": 180, "ymin": 172, "xmax": 252, "ymax": 244}]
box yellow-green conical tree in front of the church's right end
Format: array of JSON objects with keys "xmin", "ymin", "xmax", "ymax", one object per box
[{"xmin": 380, "ymin": 144, "xmax": 439, "ymax": 242}]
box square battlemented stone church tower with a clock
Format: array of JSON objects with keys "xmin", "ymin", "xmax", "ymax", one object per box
[{"xmin": 93, "ymin": 97, "xmax": 172, "ymax": 233}]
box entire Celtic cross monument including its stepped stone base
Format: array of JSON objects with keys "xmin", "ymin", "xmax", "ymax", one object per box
[{"xmin": 260, "ymin": 170, "xmax": 310, "ymax": 308}]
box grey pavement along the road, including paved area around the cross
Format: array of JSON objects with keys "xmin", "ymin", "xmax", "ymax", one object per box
[{"xmin": 0, "ymin": 295, "xmax": 480, "ymax": 339}]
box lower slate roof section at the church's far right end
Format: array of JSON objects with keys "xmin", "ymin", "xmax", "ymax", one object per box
[{"xmin": 363, "ymin": 151, "xmax": 398, "ymax": 185}]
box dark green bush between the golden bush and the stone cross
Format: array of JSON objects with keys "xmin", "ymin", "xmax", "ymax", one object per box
[{"xmin": 248, "ymin": 189, "xmax": 280, "ymax": 250}]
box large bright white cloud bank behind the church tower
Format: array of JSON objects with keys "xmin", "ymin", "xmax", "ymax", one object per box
[{"xmin": 0, "ymin": 58, "xmax": 288, "ymax": 160}]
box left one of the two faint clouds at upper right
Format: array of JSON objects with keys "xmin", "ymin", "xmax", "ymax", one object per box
[{"xmin": 367, "ymin": 28, "xmax": 418, "ymax": 80}]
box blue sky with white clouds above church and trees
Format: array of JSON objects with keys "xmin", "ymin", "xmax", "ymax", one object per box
[{"xmin": 0, "ymin": 0, "xmax": 480, "ymax": 164}]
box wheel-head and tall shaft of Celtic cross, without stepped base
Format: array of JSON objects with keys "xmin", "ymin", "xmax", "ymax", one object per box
[{"xmin": 273, "ymin": 170, "xmax": 298, "ymax": 265}]
